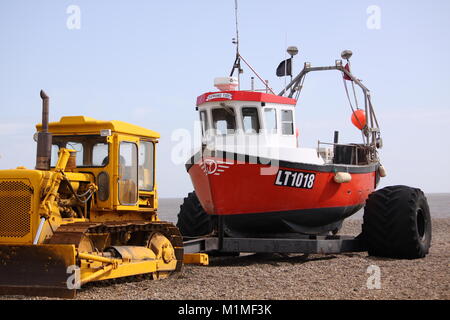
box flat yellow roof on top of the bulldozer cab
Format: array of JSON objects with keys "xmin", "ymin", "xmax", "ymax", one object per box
[{"xmin": 36, "ymin": 116, "xmax": 160, "ymax": 138}]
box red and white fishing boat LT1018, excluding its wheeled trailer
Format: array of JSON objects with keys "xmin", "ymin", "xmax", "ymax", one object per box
[{"xmin": 178, "ymin": 40, "xmax": 385, "ymax": 236}]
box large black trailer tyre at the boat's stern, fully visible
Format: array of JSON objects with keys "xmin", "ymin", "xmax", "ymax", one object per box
[{"xmin": 362, "ymin": 186, "xmax": 431, "ymax": 259}]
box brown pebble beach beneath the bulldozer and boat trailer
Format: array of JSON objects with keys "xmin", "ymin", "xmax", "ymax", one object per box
[{"xmin": 0, "ymin": 218, "xmax": 450, "ymax": 300}]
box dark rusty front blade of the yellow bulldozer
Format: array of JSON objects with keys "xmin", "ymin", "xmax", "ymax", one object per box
[{"xmin": 0, "ymin": 245, "xmax": 76, "ymax": 299}]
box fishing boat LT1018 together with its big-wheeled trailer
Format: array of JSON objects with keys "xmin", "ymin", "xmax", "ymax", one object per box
[{"xmin": 177, "ymin": 0, "xmax": 432, "ymax": 259}]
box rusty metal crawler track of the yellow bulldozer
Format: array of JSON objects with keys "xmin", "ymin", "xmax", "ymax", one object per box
[{"xmin": 47, "ymin": 221, "xmax": 184, "ymax": 271}]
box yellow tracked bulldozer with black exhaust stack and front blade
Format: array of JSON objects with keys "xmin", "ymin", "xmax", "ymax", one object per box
[{"xmin": 0, "ymin": 91, "xmax": 204, "ymax": 298}]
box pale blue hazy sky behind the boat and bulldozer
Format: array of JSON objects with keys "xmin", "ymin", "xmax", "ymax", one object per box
[{"xmin": 0, "ymin": 0, "xmax": 450, "ymax": 197}]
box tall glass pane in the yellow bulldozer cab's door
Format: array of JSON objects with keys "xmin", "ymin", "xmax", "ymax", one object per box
[{"xmin": 118, "ymin": 141, "xmax": 138, "ymax": 206}]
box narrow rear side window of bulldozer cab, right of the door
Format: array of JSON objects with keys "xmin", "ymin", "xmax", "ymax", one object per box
[{"xmin": 138, "ymin": 141, "xmax": 155, "ymax": 191}]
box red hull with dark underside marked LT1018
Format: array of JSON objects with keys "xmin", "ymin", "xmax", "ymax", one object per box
[{"xmin": 187, "ymin": 154, "xmax": 379, "ymax": 234}]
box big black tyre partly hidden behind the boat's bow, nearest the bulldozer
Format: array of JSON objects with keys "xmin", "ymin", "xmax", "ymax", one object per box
[{"xmin": 177, "ymin": 192, "xmax": 214, "ymax": 237}]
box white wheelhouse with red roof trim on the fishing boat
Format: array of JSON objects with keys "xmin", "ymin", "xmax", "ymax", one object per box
[{"xmin": 197, "ymin": 78, "xmax": 324, "ymax": 164}]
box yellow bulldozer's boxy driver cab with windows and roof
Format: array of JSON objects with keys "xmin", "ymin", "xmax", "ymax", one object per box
[{"xmin": 37, "ymin": 116, "xmax": 159, "ymax": 214}]
